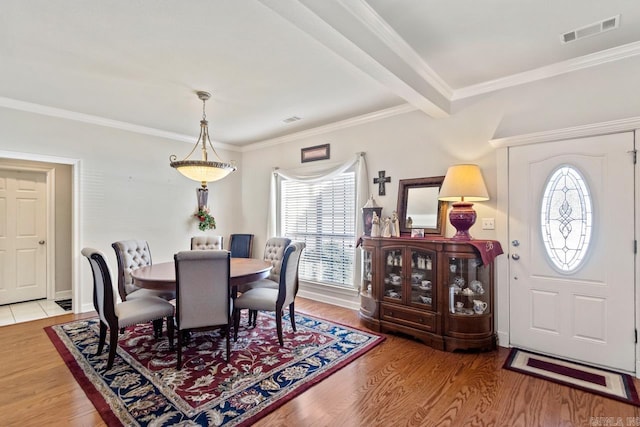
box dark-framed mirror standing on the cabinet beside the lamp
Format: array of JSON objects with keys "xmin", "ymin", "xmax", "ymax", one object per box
[{"xmin": 398, "ymin": 176, "xmax": 447, "ymax": 236}]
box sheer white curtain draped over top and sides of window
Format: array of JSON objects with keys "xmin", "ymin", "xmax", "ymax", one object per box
[{"xmin": 267, "ymin": 152, "xmax": 369, "ymax": 289}]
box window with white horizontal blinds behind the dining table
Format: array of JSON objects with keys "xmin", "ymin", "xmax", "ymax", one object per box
[{"xmin": 280, "ymin": 171, "xmax": 356, "ymax": 288}]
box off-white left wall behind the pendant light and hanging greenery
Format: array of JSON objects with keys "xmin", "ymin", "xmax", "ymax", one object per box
[{"xmin": 0, "ymin": 109, "xmax": 242, "ymax": 311}]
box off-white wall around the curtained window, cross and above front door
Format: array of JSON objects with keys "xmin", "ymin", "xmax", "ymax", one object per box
[{"xmin": 241, "ymin": 57, "xmax": 640, "ymax": 324}]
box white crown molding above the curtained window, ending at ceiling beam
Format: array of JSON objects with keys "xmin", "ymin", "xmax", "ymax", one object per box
[{"xmin": 241, "ymin": 104, "xmax": 417, "ymax": 152}]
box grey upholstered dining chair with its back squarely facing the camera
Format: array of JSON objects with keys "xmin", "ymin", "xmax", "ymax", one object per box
[{"xmin": 174, "ymin": 250, "xmax": 233, "ymax": 369}]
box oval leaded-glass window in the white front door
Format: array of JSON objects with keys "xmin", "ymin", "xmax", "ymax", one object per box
[{"xmin": 540, "ymin": 165, "xmax": 593, "ymax": 273}]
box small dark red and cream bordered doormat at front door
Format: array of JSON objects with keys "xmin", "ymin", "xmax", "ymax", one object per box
[{"xmin": 503, "ymin": 348, "xmax": 640, "ymax": 406}]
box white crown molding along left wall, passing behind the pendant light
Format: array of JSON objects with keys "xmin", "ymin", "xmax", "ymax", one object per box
[{"xmin": 0, "ymin": 97, "xmax": 240, "ymax": 151}]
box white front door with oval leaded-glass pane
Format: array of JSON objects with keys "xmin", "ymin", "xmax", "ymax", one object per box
[{"xmin": 509, "ymin": 132, "xmax": 635, "ymax": 372}]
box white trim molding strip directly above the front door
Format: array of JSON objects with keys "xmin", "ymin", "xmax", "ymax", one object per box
[{"xmin": 489, "ymin": 117, "xmax": 640, "ymax": 148}]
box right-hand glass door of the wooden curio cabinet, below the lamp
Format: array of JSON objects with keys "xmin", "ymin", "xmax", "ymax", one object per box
[{"xmin": 445, "ymin": 257, "xmax": 493, "ymax": 316}]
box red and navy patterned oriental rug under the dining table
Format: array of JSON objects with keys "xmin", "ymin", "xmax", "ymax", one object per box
[{"xmin": 45, "ymin": 312, "xmax": 384, "ymax": 426}]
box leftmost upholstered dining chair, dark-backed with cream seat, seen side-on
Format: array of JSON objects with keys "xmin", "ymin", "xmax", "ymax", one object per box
[{"xmin": 82, "ymin": 248, "xmax": 174, "ymax": 370}]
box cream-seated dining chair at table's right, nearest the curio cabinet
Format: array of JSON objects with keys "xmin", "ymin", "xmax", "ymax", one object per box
[{"xmin": 233, "ymin": 242, "xmax": 305, "ymax": 346}]
